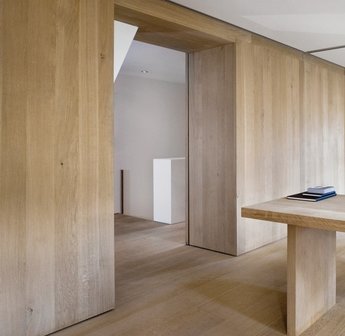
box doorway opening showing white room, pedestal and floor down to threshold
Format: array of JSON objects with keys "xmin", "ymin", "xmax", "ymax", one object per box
[{"xmin": 114, "ymin": 34, "xmax": 187, "ymax": 306}]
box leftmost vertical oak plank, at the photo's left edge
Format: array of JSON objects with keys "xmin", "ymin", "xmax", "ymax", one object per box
[{"xmin": 0, "ymin": 1, "xmax": 28, "ymax": 336}]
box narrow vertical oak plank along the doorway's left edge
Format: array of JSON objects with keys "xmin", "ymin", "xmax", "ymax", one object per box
[{"xmin": 96, "ymin": 0, "xmax": 115, "ymax": 316}]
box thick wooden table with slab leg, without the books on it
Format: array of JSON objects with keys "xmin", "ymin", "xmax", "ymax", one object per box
[{"xmin": 242, "ymin": 195, "xmax": 345, "ymax": 336}]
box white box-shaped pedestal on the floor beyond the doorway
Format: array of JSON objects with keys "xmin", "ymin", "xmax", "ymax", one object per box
[{"xmin": 153, "ymin": 158, "xmax": 186, "ymax": 224}]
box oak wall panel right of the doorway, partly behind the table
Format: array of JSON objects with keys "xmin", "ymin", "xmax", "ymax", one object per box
[{"xmin": 237, "ymin": 38, "xmax": 300, "ymax": 254}]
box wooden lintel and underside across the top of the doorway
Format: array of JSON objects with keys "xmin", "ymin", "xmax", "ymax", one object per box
[{"xmin": 114, "ymin": 0, "xmax": 251, "ymax": 52}]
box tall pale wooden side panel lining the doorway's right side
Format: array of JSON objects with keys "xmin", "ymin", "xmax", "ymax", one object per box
[{"xmin": 189, "ymin": 45, "xmax": 236, "ymax": 254}]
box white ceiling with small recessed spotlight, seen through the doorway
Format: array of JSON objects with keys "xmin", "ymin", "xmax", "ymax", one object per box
[{"xmin": 120, "ymin": 41, "xmax": 186, "ymax": 83}]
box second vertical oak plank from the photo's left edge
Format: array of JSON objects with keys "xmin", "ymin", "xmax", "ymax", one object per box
[{"xmin": 25, "ymin": 1, "xmax": 56, "ymax": 335}]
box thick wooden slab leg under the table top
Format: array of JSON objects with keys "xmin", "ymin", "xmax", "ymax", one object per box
[{"xmin": 287, "ymin": 225, "xmax": 336, "ymax": 336}]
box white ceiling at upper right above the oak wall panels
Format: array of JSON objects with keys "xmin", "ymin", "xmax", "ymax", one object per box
[{"xmin": 171, "ymin": 0, "xmax": 345, "ymax": 67}]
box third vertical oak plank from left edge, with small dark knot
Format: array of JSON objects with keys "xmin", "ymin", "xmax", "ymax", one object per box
[{"xmin": 54, "ymin": 1, "xmax": 80, "ymax": 329}]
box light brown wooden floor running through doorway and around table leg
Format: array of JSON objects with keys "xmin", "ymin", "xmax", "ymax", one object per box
[{"xmin": 53, "ymin": 216, "xmax": 345, "ymax": 336}]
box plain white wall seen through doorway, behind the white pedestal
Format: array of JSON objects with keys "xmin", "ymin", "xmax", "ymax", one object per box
[{"xmin": 114, "ymin": 72, "xmax": 186, "ymax": 219}]
